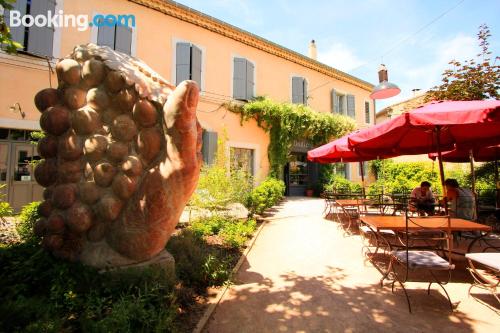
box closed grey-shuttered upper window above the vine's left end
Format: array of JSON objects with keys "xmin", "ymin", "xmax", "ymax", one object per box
[{"xmin": 233, "ymin": 58, "xmax": 255, "ymax": 101}]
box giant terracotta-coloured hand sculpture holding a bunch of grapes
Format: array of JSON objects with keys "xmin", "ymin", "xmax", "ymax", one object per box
[{"xmin": 35, "ymin": 44, "xmax": 202, "ymax": 268}]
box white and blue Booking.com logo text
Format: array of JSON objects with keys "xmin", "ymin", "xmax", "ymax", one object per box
[{"xmin": 9, "ymin": 10, "xmax": 135, "ymax": 31}]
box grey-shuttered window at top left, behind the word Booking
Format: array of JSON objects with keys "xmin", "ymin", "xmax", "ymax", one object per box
[{"xmin": 4, "ymin": 0, "xmax": 56, "ymax": 57}]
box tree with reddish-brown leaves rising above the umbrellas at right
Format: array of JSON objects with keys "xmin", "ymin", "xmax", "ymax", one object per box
[{"xmin": 426, "ymin": 24, "xmax": 500, "ymax": 101}]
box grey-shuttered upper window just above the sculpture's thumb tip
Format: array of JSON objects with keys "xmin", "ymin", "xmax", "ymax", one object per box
[{"xmin": 175, "ymin": 43, "xmax": 201, "ymax": 90}]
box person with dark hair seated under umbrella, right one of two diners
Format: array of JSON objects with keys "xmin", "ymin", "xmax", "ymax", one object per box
[{"xmin": 444, "ymin": 178, "xmax": 476, "ymax": 220}]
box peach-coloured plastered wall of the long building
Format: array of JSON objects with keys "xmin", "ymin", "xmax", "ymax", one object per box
[{"xmin": 0, "ymin": 0, "xmax": 374, "ymax": 181}]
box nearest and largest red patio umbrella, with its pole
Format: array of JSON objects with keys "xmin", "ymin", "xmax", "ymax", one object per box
[{"xmin": 348, "ymin": 100, "xmax": 500, "ymax": 191}]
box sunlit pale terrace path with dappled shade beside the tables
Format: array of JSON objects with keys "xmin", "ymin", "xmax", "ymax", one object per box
[{"xmin": 205, "ymin": 198, "xmax": 500, "ymax": 333}]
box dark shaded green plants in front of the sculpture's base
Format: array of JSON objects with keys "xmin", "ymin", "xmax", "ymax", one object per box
[{"xmin": 0, "ymin": 243, "xmax": 178, "ymax": 332}]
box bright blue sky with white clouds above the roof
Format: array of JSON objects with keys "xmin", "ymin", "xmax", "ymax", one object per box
[{"xmin": 173, "ymin": 0, "xmax": 500, "ymax": 111}]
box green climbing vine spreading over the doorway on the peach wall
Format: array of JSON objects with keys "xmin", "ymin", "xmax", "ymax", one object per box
[{"xmin": 226, "ymin": 97, "xmax": 355, "ymax": 178}]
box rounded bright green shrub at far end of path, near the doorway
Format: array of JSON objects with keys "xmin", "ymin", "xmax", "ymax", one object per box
[{"xmin": 247, "ymin": 177, "xmax": 285, "ymax": 214}]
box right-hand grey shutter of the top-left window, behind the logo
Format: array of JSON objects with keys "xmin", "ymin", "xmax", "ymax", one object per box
[{"xmin": 27, "ymin": 0, "xmax": 56, "ymax": 57}]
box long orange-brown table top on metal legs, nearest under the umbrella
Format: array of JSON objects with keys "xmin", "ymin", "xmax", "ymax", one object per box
[{"xmin": 360, "ymin": 215, "xmax": 492, "ymax": 283}]
